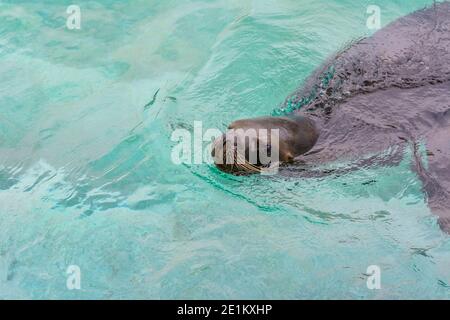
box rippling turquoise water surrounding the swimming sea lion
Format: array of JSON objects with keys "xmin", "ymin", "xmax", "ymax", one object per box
[{"xmin": 0, "ymin": 0, "xmax": 450, "ymax": 299}]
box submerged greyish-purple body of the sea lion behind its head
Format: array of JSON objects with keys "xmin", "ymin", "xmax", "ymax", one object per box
[{"xmin": 289, "ymin": 2, "xmax": 450, "ymax": 233}]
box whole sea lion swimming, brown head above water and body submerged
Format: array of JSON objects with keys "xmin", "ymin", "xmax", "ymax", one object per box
[{"xmin": 212, "ymin": 2, "xmax": 450, "ymax": 233}]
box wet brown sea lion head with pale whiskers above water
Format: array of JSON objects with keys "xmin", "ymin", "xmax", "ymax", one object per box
[{"xmin": 211, "ymin": 115, "xmax": 319, "ymax": 174}]
